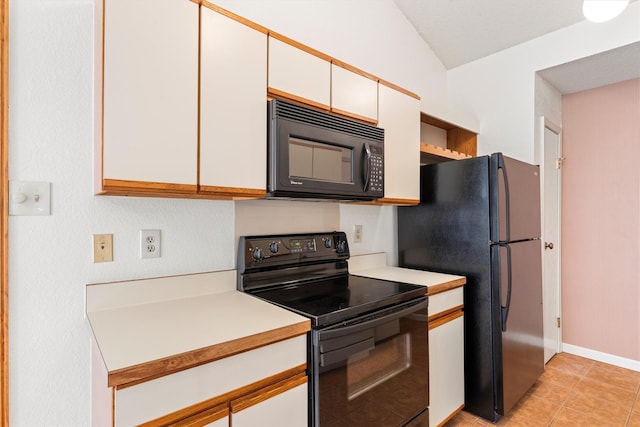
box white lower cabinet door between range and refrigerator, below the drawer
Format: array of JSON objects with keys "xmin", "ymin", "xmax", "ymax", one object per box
[{"xmin": 429, "ymin": 316, "xmax": 464, "ymax": 427}]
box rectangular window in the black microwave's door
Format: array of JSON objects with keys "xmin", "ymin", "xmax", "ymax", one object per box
[{"xmin": 289, "ymin": 136, "xmax": 353, "ymax": 184}]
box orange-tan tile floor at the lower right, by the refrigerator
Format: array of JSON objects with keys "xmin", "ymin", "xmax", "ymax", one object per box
[{"xmin": 445, "ymin": 353, "xmax": 640, "ymax": 427}]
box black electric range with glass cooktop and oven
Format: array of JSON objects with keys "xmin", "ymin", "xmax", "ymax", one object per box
[{"xmin": 238, "ymin": 231, "xmax": 429, "ymax": 427}]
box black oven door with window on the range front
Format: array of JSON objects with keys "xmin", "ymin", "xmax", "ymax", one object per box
[{"xmin": 311, "ymin": 297, "xmax": 429, "ymax": 427}]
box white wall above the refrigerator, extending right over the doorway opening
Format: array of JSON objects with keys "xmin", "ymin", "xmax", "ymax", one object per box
[{"xmin": 448, "ymin": 2, "xmax": 640, "ymax": 162}]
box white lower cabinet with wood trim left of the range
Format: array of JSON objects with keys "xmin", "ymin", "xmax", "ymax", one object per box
[{"xmin": 113, "ymin": 335, "xmax": 308, "ymax": 427}]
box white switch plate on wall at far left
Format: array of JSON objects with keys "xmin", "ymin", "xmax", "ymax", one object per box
[{"xmin": 9, "ymin": 181, "xmax": 51, "ymax": 215}]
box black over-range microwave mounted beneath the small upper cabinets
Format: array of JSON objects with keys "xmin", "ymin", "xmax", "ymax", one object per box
[{"xmin": 267, "ymin": 100, "xmax": 384, "ymax": 200}]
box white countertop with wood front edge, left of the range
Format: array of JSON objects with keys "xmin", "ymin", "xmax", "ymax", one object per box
[{"xmin": 87, "ymin": 272, "xmax": 310, "ymax": 388}]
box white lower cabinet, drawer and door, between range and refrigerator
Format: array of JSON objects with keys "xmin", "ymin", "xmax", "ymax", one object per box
[{"xmin": 429, "ymin": 287, "xmax": 464, "ymax": 427}]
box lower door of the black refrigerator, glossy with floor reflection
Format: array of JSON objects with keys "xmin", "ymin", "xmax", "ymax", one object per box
[{"xmin": 492, "ymin": 240, "xmax": 544, "ymax": 415}]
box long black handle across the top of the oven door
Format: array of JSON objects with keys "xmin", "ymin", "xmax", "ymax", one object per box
[{"xmin": 318, "ymin": 297, "xmax": 429, "ymax": 340}]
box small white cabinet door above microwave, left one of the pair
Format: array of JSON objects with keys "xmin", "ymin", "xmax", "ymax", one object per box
[{"xmin": 269, "ymin": 37, "xmax": 331, "ymax": 110}]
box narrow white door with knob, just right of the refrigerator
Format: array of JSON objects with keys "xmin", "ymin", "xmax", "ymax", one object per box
[{"xmin": 542, "ymin": 119, "xmax": 562, "ymax": 363}]
